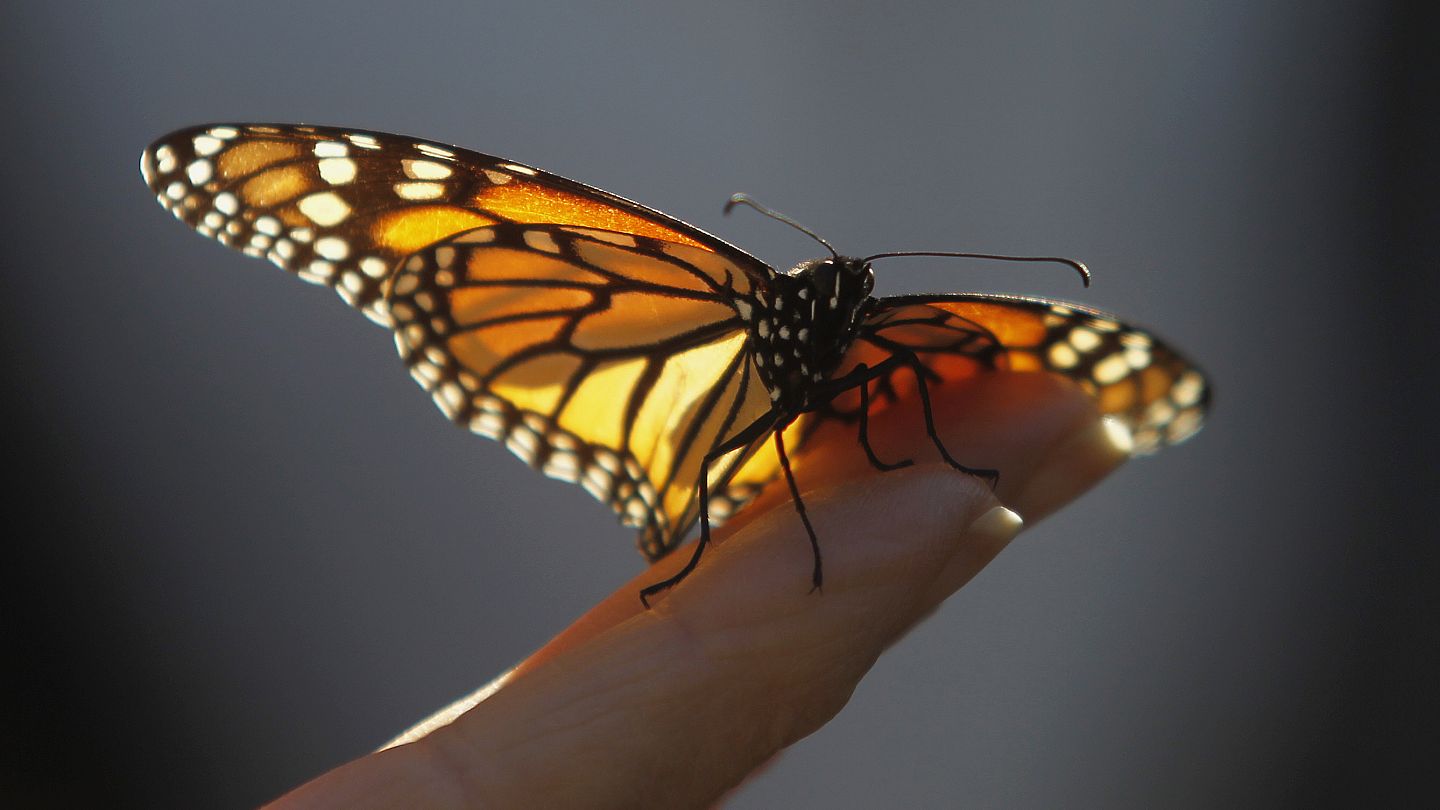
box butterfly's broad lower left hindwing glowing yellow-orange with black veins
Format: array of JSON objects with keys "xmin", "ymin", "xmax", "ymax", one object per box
[{"xmin": 390, "ymin": 223, "xmax": 772, "ymax": 558}]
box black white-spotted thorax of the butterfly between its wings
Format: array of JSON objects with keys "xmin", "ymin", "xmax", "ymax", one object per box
[{"xmin": 747, "ymin": 257, "xmax": 876, "ymax": 412}]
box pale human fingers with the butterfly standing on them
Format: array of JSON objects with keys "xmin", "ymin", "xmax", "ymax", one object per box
[{"xmin": 274, "ymin": 375, "xmax": 1128, "ymax": 810}]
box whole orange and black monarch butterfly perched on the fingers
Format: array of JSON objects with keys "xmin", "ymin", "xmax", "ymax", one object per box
[{"xmin": 140, "ymin": 124, "xmax": 1208, "ymax": 600}]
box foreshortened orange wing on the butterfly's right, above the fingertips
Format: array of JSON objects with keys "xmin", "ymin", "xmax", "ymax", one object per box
[{"xmin": 827, "ymin": 294, "xmax": 1210, "ymax": 454}]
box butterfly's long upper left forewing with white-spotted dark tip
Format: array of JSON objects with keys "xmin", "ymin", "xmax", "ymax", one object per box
[{"xmin": 140, "ymin": 124, "xmax": 763, "ymax": 324}]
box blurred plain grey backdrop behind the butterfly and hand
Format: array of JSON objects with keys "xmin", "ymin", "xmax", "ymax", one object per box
[{"xmin": 0, "ymin": 0, "xmax": 1440, "ymax": 807}]
